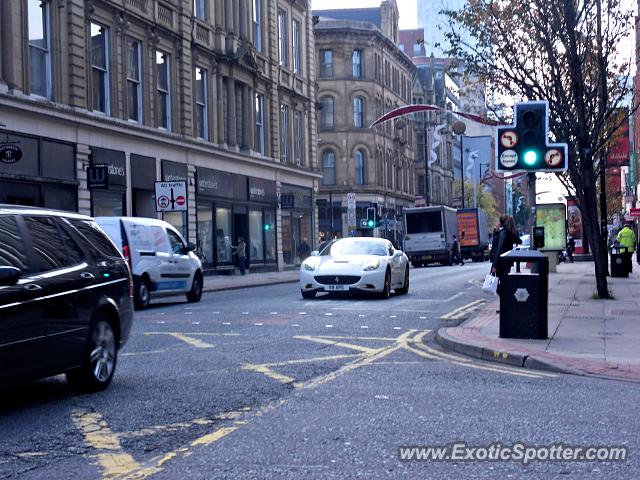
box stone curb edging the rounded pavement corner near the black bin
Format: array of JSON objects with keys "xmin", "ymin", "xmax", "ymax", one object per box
[{"xmin": 435, "ymin": 327, "xmax": 588, "ymax": 376}]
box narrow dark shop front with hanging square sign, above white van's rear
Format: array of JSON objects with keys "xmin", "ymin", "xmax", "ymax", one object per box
[{"xmin": 90, "ymin": 147, "xmax": 127, "ymax": 217}]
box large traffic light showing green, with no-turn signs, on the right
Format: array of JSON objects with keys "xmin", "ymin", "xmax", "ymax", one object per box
[{"xmin": 496, "ymin": 100, "xmax": 568, "ymax": 172}]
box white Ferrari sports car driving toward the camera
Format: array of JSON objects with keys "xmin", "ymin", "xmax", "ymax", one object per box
[{"xmin": 300, "ymin": 237, "xmax": 409, "ymax": 298}]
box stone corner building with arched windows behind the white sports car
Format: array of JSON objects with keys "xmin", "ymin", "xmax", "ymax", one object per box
[{"xmin": 313, "ymin": 0, "xmax": 415, "ymax": 239}]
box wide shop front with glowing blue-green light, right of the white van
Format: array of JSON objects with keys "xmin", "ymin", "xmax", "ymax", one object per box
[{"xmin": 196, "ymin": 168, "xmax": 277, "ymax": 272}]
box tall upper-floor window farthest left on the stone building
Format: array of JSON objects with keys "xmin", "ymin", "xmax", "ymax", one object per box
[{"xmin": 28, "ymin": 0, "xmax": 51, "ymax": 98}]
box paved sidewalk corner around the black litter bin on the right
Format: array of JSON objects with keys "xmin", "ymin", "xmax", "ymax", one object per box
[{"xmin": 436, "ymin": 258, "xmax": 640, "ymax": 381}]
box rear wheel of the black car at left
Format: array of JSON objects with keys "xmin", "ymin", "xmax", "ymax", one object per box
[{"xmin": 67, "ymin": 313, "xmax": 118, "ymax": 392}]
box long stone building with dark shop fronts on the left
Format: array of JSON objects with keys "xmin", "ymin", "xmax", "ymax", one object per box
[{"xmin": 0, "ymin": 0, "xmax": 320, "ymax": 271}]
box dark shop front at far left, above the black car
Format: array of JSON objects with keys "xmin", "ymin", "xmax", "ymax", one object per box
[{"xmin": 0, "ymin": 130, "xmax": 78, "ymax": 212}]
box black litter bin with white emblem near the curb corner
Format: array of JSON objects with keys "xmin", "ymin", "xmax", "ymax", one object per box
[{"xmin": 499, "ymin": 250, "xmax": 549, "ymax": 339}]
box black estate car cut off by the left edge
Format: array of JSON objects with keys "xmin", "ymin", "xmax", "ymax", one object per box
[{"xmin": 0, "ymin": 205, "xmax": 133, "ymax": 391}]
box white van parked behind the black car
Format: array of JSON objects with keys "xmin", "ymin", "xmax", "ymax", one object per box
[{"xmin": 95, "ymin": 217, "xmax": 203, "ymax": 309}]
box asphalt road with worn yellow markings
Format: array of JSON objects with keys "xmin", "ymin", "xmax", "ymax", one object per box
[{"xmin": 0, "ymin": 263, "xmax": 640, "ymax": 479}]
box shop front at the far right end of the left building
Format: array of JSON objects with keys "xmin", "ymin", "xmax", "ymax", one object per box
[{"xmin": 280, "ymin": 184, "xmax": 318, "ymax": 266}]
